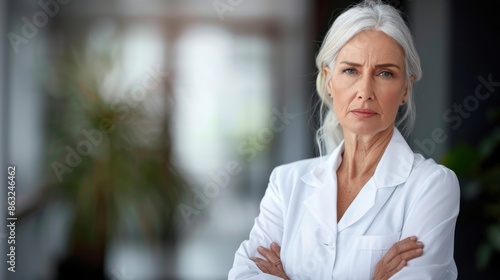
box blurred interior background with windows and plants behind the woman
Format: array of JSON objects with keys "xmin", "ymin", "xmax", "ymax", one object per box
[{"xmin": 0, "ymin": 0, "xmax": 500, "ymax": 280}]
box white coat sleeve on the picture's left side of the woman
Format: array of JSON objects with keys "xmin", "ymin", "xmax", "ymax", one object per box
[{"xmin": 228, "ymin": 170, "xmax": 284, "ymax": 280}]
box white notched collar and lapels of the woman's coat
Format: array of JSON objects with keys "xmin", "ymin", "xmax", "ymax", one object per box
[{"xmin": 301, "ymin": 128, "xmax": 414, "ymax": 232}]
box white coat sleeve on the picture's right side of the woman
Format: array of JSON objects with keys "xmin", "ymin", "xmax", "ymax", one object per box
[{"xmin": 391, "ymin": 166, "xmax": 460, "ymax": 280}]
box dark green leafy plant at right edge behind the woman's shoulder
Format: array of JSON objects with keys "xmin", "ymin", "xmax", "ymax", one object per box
[{"xmin": 443, "ymin": 106, "xmax": 500, "ymax": 271}]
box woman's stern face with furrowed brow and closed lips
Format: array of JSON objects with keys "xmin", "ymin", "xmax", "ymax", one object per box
[{"xmin": 325, "ymin": 30, "xmax": 407, "ymax": 135}]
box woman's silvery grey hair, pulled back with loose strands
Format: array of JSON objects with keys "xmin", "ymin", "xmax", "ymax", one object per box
[{"xmin": 316, "ymin": 0, "xmax": 422, "ymax": 155}]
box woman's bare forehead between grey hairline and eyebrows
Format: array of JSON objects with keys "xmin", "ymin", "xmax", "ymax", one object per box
[{"xmin": 337, "ymin": 30, "xmax": 404, "ymax": 65}]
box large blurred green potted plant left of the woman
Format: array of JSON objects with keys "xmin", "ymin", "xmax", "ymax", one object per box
[{"xmin": 21, "ymin": 44, "xmax": 186, "ymax": 279}]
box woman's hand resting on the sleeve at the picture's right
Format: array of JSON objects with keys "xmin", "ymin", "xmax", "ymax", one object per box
[{"xmin": 374, "ymin": 236, "xmax": 424, "ymax": 280}]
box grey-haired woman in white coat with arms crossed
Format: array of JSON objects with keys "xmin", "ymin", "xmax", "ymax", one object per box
[{"xmin": 229, "ymin": 1, "xmax": 460, "ymax": 280}]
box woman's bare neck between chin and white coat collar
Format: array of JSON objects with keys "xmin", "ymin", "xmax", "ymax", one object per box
[{"xmin": 339, "ymin": 127, "xmax": 394, "ymax": 180}]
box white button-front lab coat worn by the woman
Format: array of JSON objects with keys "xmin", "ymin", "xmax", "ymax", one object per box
[{"xmin": 228, "ymin": 129, "xmax": 460, "ymax": 280}]
